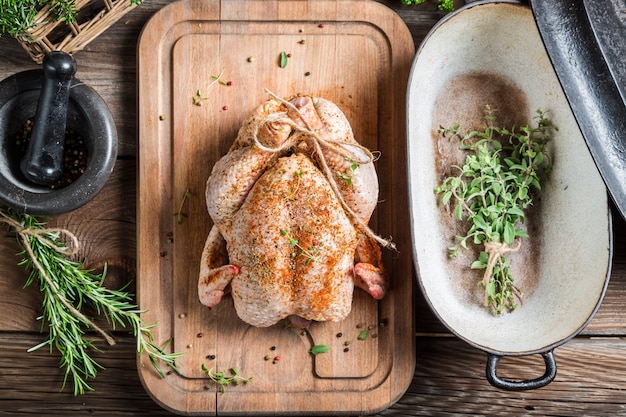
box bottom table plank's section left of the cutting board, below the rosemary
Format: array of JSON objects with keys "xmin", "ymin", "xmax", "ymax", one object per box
[{"xmin": 0, "ymin": 331, "xmax": 173, "ymax": 417}]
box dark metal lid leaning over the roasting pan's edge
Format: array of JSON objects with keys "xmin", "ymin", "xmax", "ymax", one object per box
[{"xmin": 530, "ymin": 0, "xmax": 626, "ymax": 219}]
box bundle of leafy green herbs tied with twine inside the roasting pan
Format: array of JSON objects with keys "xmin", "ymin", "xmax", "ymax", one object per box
[{"xmin": 435, "ymin": 106, "xmax": 556, "ymax": 315}]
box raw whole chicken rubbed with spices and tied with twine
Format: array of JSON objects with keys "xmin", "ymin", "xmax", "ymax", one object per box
[{"xmin": 198, "ymin": 92, "xmax": 387, "ymax": 327}]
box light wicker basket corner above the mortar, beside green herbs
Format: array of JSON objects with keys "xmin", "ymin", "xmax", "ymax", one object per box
[{"xmin": 19, "ymin": 0, "xmax": 136, "ymax": 64}]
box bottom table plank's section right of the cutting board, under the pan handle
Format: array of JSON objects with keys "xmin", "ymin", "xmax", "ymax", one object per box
[{"xmin": 398, "ymin": 337, "xmax": 626, "ymax": 416}]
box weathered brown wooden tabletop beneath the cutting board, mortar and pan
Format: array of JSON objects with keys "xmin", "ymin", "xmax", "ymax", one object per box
[{"xmin": 0, "ymin": 0, "xmax": 626, "ymax": 416}]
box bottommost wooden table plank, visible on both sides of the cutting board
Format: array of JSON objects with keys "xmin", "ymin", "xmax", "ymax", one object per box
[{"xmin": 0, "ymin": 332, "xmax": 626, "ymax": 417}]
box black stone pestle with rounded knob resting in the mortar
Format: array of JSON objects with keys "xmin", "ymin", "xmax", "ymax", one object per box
[{"xmin": 20, "ymin": 51, "xmax": 76, "ymax": 185}]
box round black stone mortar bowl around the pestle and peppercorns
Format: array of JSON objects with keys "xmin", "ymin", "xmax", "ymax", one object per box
[{"xmin": 0, "ymin": 66, "xmax": 117, "ymax": 215}]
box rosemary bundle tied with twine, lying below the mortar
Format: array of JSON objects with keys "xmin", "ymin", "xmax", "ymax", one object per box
[{"xmin": 0, "ymin": 207, "xmax": 183, "ymax": 395}]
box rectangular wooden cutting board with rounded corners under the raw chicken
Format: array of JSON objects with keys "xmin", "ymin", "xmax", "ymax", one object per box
[{"xmin": 137, "ymin": 0, "xmax": 415, "ymax": 415}]
